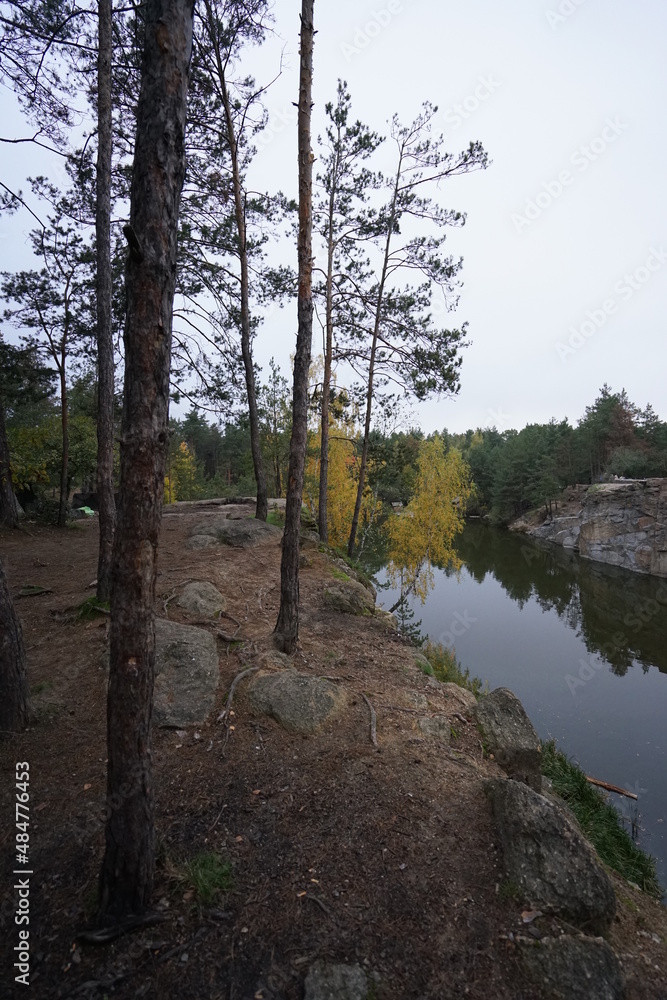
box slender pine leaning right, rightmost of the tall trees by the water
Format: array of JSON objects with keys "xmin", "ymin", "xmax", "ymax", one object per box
[{"xmin": 348, "ymin": 103, "xmax": 488, "ymax": 556}]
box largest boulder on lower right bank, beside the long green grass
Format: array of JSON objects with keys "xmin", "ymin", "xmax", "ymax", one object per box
[{"xmin": 485, "ymin": 778, "xmax": 616, "ymax": 934}]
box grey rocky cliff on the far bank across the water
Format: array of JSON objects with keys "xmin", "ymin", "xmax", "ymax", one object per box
[{"xmin": 512, "ymin": 479, "xmax": 667, "ymax": 577}]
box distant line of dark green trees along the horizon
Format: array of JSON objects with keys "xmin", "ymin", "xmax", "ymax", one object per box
[{"xmin": 7, "ymin": 368, "xmax": 667, "ymax": 523}]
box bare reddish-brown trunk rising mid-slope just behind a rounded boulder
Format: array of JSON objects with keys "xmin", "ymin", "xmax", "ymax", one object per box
[{"xmin": 275, "ymin": 0, "xmax": 314, "ymax": 654}]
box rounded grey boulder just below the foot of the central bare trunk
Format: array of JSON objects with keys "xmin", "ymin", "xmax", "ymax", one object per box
[{"xmin": 248, "ymin": 670, "xmax": 347, "ymax": 733}]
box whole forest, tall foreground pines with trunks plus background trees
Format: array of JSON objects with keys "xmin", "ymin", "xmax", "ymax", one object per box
[{"xmin": 0, "ymin": 0, "xmax": 667, "ymax": 933}]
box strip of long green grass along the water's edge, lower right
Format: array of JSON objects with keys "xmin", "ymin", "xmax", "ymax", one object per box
[{"xmin": 542, "ymin": 740, "xmax": 663, "ymax": 899}]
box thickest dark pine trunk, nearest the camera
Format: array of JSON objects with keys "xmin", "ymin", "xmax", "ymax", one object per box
[{"xmin": 98, "ymin": 0, "xmax": 193, "ymax": 924}]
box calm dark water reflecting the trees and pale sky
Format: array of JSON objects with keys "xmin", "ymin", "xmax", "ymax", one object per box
[{"xmin": 376, "ymin": 521, "xmax": 667, "ymax": 888}]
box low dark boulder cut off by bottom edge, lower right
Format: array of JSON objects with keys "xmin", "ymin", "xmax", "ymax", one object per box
[{"xmin": 520, "ymin": 934, "xmax": 625, "ymax": 1000}]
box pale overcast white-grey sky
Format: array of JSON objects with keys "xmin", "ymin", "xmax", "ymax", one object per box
[{"xmin": 0, "ymin": 0, "xmax": 667, "ymax": 432}]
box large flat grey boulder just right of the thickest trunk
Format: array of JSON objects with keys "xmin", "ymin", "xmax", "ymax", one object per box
[{"xmin": 153, "ymin": 618, "xmax": 220, "ymax": 728}]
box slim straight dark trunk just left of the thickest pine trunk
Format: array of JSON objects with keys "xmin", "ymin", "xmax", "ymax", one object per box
[{"xmin": 95, "ymin": 0, "xmax": 116, "ymax": 601}]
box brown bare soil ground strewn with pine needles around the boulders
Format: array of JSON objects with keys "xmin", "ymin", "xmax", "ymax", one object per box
[{"xmin": 0, "ymin": 508, "xmax": 667, "ymax": 1000}]
